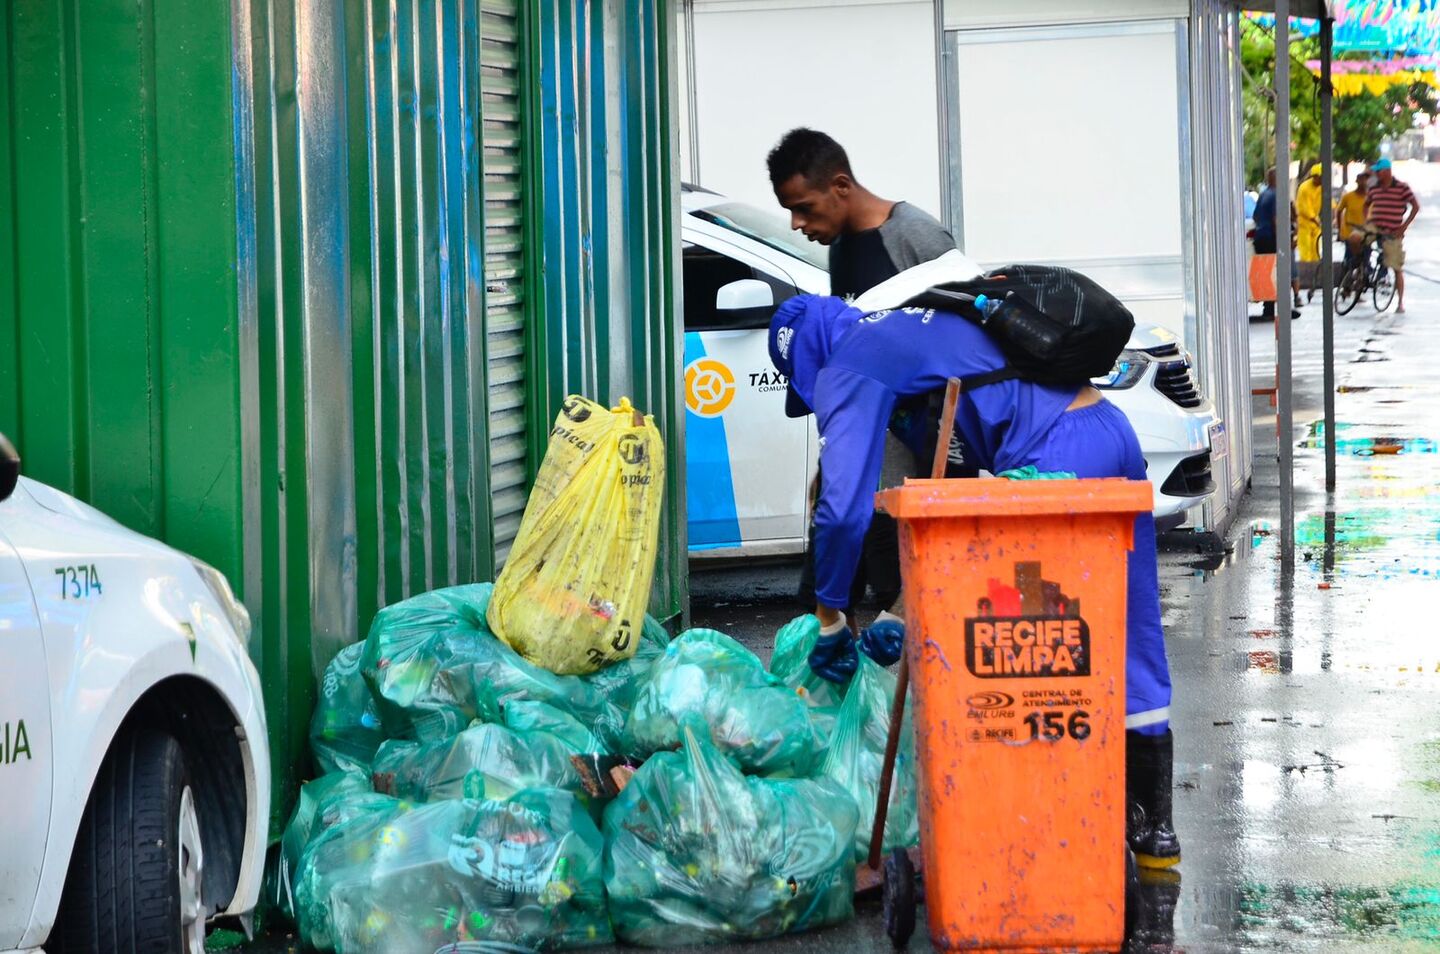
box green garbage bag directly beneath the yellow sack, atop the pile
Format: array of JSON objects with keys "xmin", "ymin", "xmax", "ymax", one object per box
[{"xmin": 360, "ymin": 584, "xmax": 664, "ymax": 749}]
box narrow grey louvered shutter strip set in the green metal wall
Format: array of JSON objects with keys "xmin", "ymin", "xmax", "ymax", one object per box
[{"xmin": 480, "ymin": 0, "xmax": 526, "ymax": 568}]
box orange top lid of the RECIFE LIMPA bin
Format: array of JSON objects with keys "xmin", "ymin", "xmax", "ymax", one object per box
[{"xmin": 876, "ymin": 477, "xmax": 1155, "ymax": 520}]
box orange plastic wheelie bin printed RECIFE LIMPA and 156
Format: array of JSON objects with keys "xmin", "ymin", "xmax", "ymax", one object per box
[{"xmin": 876, "ymin": 478, "xmax": 1152, "ymax": 951}]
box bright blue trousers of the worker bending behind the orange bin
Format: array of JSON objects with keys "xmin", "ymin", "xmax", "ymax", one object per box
[{"xmin": 1017, "ymin": 401, "xmax": 1171, "ymax": 735}]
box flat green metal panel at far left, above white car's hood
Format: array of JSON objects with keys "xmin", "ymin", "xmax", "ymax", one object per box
[{"xmin": 0, "ymin": 0, "xmax": 240, "ymax": 579}]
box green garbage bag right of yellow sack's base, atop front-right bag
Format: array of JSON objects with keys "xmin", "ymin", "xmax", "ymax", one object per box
[{"xmin": 625, "ymin": 630, "xmax": 818, "ymax": 775}]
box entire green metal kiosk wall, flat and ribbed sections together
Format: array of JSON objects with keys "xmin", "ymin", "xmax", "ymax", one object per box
[{"xmin": 0, "ymin": 0, "xmax": 685, "ymax": 817}]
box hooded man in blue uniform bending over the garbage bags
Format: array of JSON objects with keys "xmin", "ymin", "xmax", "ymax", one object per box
[{"xmin": 770, "ymin": 295, "xmax": 1179, "ymax": 868}]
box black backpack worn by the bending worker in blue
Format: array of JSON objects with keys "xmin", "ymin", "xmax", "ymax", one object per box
[{"xmin": 906, "ymin": 265, "xmax": 1135, "ymax": 391}]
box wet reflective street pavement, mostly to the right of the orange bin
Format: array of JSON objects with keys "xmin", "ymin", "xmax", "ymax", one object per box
[{"xmin": 679, "ymin": 181, "xmax": 1440, "ymax": 953}]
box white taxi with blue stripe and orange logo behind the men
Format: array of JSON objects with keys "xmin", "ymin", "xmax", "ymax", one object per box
[{"xmin": 681, "ymin": 186, "xmax": 1218, "ymax": 558}]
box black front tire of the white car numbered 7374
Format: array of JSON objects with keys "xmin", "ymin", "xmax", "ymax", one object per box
[{"xmin": 46, "ymin": 729, "xmax": 206, "ymax": 954}]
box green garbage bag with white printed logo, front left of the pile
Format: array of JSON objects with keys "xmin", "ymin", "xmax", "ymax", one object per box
[{"xmin": 295, "ymin": 788, "xmax": 613, "ymax": 954}]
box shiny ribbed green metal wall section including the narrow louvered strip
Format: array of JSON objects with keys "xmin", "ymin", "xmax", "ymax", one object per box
[{"xmin": 236, "ymin": 0, "xmax": 552, "ymax": 818}]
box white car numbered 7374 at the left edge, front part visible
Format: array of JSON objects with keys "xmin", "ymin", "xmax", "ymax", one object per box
[{"xmin": 0, "ymin": 437, "xmax": 271, "ymax": 954}]
